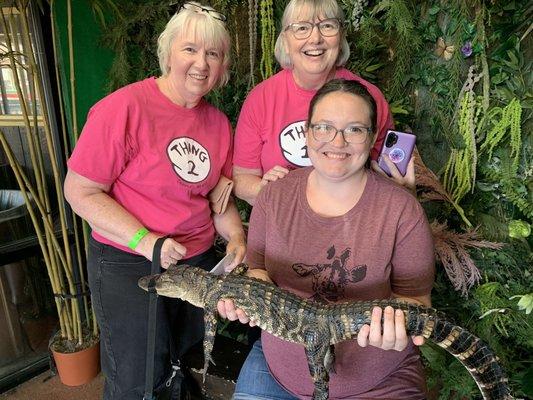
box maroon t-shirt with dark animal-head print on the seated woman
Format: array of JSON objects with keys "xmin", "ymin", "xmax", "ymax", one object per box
[{"xmin": 247, "ymin": 167, "xmax": 434, "ymax": 399}]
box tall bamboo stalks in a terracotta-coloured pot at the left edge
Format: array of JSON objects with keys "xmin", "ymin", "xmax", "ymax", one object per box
[{"xmin": 0, "ymin": 1, "xmax": 99, "ymax": 386}]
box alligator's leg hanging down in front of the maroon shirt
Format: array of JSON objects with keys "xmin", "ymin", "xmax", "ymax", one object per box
[{"xmin": 305, "ymin": 331, "xmax": 329, "ymax": 400}]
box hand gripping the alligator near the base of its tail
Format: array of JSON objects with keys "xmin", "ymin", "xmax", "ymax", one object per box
[{"xmin": 357, "ymin": 306, "xmax": 424, "ymax": 351}]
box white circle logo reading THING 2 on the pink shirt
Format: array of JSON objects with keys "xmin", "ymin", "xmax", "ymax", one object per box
[{"xmin": 167, "ymin": 137, "xmax": 211, "ymax": 183}]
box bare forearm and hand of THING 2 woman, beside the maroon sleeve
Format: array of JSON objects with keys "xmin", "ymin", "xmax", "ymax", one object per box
[{"xmin": 213, "ymin": 197, "xmax": 246, "ymax": 271}]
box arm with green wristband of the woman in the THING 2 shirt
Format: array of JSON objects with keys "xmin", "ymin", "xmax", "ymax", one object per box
[{"xmin": 65, "ymin": 169, "xmax": 186, "ymax": 267}]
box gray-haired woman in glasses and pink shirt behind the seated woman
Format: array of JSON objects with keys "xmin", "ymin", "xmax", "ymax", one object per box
[{"xmin": 233, "ymin": 0, "xmax": 415, "ymax": 205}]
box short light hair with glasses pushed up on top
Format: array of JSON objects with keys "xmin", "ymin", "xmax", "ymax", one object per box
[{"xmin": 157, "ymin": 2, "xmax": 231, "ymax": 87}]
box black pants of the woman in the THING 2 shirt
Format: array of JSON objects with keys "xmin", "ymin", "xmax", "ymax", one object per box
[{"xmin": 87, "ymin": 238, "xmax": 216, "ymax": 400}]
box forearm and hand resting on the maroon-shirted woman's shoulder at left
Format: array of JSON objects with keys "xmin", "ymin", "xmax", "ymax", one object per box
[{"xmin": 233, "ymin": 165, "xmax": 289, "ymax": 206}]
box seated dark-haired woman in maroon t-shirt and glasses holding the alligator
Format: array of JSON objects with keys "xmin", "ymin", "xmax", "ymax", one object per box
[{"xmin": 219, "ymin": 80, "xmax": 434, "ymax": 400}]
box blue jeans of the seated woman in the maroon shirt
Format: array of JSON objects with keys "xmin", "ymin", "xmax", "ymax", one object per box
[{"xmin": 233, "ymin": 340, "xmax": 297, "ymax": 400}]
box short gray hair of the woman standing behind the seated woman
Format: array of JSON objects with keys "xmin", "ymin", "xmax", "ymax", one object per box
[{"xmin": 274, "ymin": 0, "xmax": 350, "ymax": 68}]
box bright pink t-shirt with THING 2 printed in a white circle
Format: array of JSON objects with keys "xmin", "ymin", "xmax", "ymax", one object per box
[{"xmin": 68, "ymin": 78, "xmax": 232, "ymax": 257}]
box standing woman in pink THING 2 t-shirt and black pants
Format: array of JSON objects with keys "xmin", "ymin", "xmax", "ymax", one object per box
[{"xmin": 65, "ymin": 3, "xmax": 245, "ymax": 399}]
